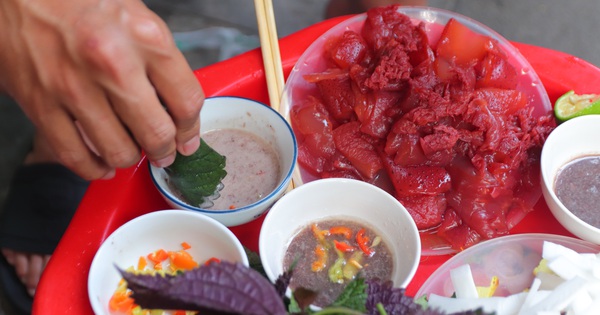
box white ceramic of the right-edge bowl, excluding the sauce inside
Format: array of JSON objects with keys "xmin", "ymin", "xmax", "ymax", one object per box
[{"xmin": 540, "ymin": 115, "xmax": 600, "ymax": 244}]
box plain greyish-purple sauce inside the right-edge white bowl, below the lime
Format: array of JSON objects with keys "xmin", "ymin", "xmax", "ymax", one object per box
[{"xmin": 555, "ymin": 156, "xmax": 600, "ymax": 228}]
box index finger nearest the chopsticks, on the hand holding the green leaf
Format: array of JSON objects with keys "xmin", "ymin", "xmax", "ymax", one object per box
[{"xmin": 127, "ymin": 12, "xmax": 204, "ymax": 155}]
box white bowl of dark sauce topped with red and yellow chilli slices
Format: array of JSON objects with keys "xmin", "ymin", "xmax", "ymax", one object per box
[{"xmin": 259, "ymin": 178, "xmax": 421, "ymax": 307}]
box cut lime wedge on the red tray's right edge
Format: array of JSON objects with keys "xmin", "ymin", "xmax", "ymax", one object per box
[{"xmin": 554, "ymin": 91, "xmax": 600, "ymax": 122}]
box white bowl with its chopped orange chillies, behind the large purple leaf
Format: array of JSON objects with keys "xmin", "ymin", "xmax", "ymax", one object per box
[{"xmin": 87, "ymin": 209, "xmax": 249, "ymax": 315}]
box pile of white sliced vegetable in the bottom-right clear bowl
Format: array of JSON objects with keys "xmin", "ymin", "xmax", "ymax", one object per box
[{"xmin": 429, "ymin": 242, "xmax": 600, "ymax": 315}]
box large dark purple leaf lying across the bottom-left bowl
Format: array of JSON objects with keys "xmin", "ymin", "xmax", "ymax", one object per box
[{"xmin": 120, "ymin": 261, "xmax": 287, "ymax": 315}]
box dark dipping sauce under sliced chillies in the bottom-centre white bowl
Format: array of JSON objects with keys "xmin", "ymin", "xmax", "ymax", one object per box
[{"xmin": 283, "ymin": 219, "xmax": 393, "ymax": 307}]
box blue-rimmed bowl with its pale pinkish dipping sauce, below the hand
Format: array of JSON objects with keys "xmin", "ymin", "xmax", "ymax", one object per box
[{"xmin": 148, "ymin": 96, "xmax": 298, "ymax": 226}]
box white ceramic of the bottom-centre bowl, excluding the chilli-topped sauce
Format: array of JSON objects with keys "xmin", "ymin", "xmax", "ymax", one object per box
[{"xmin": 259, "ymin": 178, "xmax": 421, "ymax": 302}]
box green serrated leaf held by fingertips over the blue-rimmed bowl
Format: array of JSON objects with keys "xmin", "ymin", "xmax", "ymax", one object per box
[{"xmin": 165, "ymin": 139, "xmax": 227, "ymax": 206}]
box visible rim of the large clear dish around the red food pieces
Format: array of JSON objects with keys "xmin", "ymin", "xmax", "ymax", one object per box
[{"xmin": 281, "ymin": 6, "xmax": 552, "ymax": 255}]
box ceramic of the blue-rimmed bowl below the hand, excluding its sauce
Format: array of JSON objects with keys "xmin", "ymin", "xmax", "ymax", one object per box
[{"xmin": 148, "ymin": 96, "xmax": 298, "ymax": 226}]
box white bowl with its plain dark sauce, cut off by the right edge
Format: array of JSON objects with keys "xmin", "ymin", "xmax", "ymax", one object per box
[{"xmin": 541, "ymin": 115, "xmax": 600, "ymax": 244}]
